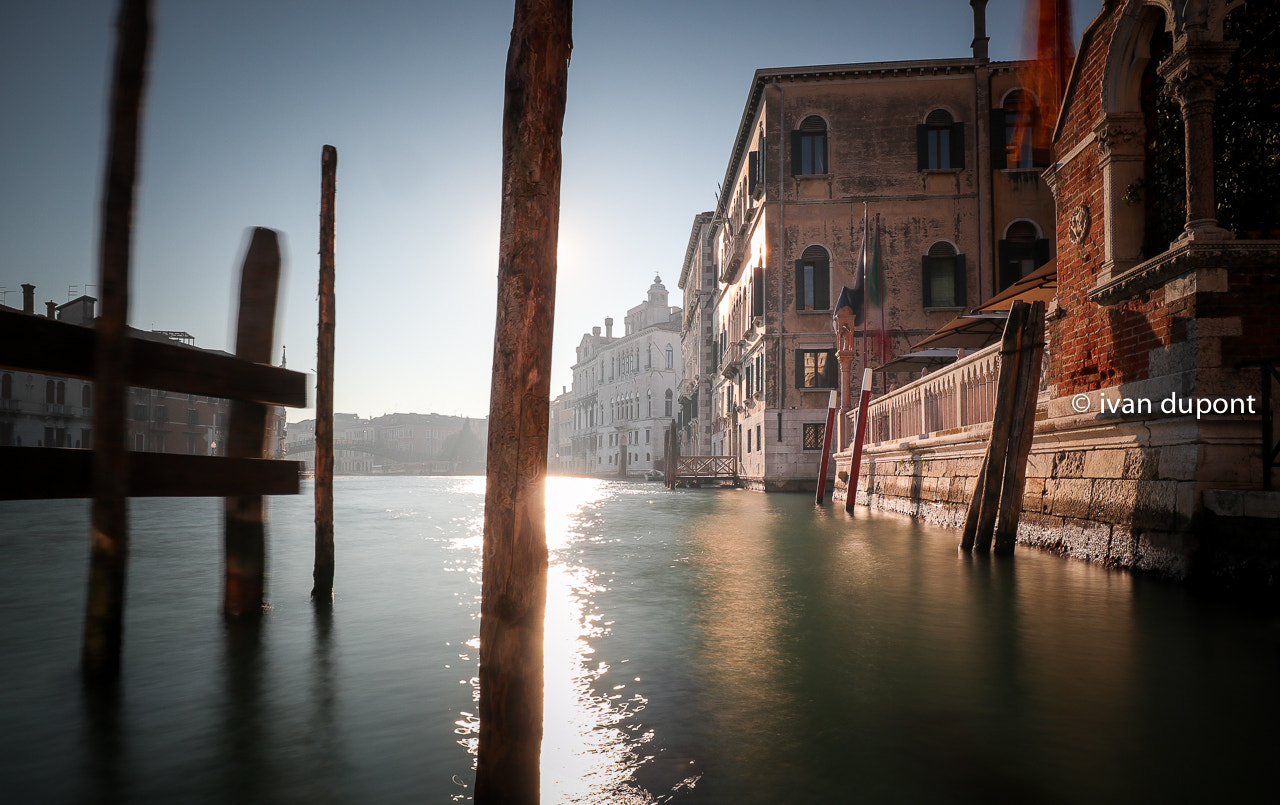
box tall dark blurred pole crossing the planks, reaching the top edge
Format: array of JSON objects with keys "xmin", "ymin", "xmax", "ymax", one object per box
[{"xmin": 81, "ymin": 0, "xmax": 151, "ymax": 682}]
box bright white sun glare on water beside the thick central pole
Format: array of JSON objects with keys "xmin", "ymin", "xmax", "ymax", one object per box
[{"xmin": 454, "ymin": 477, "xmax": 655, "ymax": 805}]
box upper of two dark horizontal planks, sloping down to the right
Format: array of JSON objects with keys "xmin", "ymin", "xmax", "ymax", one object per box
[{"xmin": 0, "ymin": 308, "xmax": 307, "ymax": 408}]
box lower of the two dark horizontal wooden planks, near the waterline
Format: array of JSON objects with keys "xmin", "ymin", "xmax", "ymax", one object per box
[{"xmin": 0, "ymin": 447, "xmax": 303, "ymax": 500}]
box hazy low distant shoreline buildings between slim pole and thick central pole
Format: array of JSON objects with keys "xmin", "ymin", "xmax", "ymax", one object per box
[{"xmin": 284, "ymin": 413, "xmax": 489, "ymax": 475}]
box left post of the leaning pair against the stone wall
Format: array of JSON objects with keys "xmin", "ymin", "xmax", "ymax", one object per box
[{"xmin": 960, "ymin": 301, "xmax": 1028, "ymax": 552}]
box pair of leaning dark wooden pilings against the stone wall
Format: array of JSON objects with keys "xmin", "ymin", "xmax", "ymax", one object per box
[{"xmin": 960, "ymin": 301, "xmax": 1044, "ymax": 553}]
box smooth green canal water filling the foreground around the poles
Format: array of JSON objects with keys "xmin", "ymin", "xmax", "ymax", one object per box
[{"xmin": 0, "ymin": 477, "xmax": 1280, "ymax": 804}]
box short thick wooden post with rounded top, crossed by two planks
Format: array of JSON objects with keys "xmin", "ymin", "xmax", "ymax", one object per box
[{"xmin": 223, "ymin": 227, "xmax": 280, "ymax": 619}]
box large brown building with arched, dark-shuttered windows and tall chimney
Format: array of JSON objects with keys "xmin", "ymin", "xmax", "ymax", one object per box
[{"xmin": 686, "ymin": 1, "xmax": 1053, "ymax": 490}]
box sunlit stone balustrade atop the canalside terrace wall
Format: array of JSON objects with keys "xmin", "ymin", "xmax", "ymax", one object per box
[{"xmin": 867, "ymin": 344, "xmax": 1000, "ymax": 443}]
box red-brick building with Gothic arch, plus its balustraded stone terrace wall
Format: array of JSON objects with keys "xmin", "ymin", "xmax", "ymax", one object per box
[{"xmin": 837, "ymin": 0, "xmax": 1280, "ymax": 591}]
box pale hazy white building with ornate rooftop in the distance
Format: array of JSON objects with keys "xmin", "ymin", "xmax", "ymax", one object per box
[{"xmin": 567, "ymin": 276, "xmax": 682, "ymax": 476}]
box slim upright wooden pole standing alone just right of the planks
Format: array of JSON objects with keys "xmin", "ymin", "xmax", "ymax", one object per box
[{"xmin": 311, "ymin": 146, "xmax": 338, "ymax": 604}]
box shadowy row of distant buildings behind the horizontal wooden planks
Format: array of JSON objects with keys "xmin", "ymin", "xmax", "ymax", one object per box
[{"xmin": 0, "ymin": 285, "xmax": 284, "ymax": 457}]
